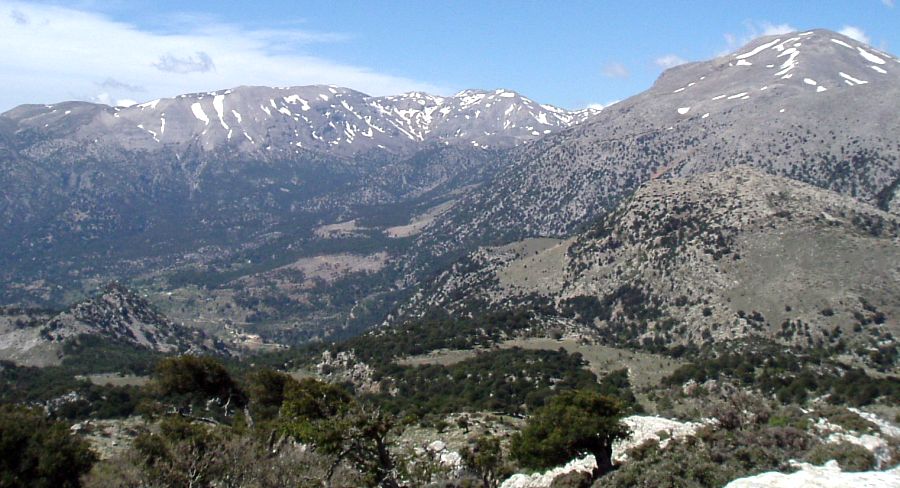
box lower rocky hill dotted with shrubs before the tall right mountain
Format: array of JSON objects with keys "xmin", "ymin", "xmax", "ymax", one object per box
[{"xmin": 409, "ymin": 166, "xmax": 900, "ymax": 362}]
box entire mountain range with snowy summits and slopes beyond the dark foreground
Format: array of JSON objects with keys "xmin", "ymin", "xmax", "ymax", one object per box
[{"xmin": 0, "ymin": 30, "xmax": 900, "ymax": 362}]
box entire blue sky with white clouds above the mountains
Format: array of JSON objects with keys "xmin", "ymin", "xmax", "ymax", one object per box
[{"xmin": 0, "ymin": 0, "xmax": 900, "ymax": 111}]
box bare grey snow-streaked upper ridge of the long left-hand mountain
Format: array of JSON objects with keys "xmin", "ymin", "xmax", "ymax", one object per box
[{"xmin": 3, "ymin": 85, "xmax": 599, "ymax": 155}]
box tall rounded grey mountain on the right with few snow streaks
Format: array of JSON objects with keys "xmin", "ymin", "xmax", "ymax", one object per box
[{"xmin": 421, "ymin": 30, "xmax": 900, "ymax": 255}]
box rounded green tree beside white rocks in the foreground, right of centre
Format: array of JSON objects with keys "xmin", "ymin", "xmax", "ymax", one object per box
[{"xmin": 511, "ymin": 390, "xmax": 629, "ymax": 475}]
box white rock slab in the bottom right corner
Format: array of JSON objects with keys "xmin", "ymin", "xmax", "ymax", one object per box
[{"xmin": 725, "ymin": 461, "xmax": 900, "ymax": 488}]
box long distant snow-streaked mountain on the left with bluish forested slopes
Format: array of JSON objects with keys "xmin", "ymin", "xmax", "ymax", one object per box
[{"xmin": 0, "ymin": 82, "xmax": 598, "ymax": 306}]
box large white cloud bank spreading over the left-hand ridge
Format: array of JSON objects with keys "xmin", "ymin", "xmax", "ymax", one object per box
[{"xmin": 0, "ymin": 0, "xmax": 448, "ymax": 111}]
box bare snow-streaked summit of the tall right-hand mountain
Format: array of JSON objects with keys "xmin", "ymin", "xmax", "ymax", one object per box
[{"xmin": 624, "ymin": 29, "xmax": 900, "ymax": 127}]
